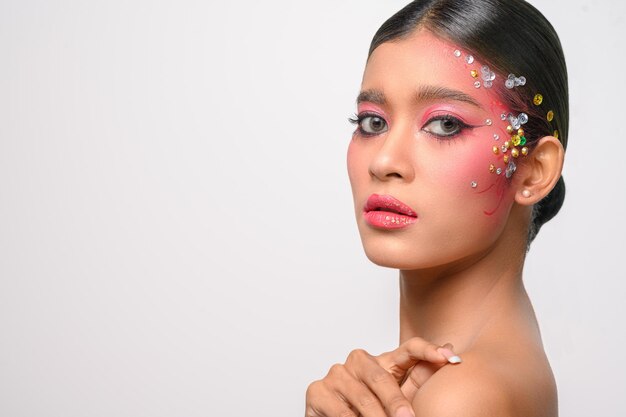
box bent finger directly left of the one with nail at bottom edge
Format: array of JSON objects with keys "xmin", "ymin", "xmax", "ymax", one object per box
[{"xmin": 324, "ymin": 360, "xmax": 386, "ymax": 417}]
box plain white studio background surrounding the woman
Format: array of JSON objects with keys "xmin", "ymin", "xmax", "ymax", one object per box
[{"xmin": 0, "ymin": 0, "xmax": 626, "ymax": 417}]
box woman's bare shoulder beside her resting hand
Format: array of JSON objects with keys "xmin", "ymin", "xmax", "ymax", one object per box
[{"xmin": 413, "ymin": 346, "xmax": 558, "ymax": 417}]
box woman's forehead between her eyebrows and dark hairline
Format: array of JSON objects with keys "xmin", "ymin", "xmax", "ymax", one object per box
[{"xmin": 361, "ymin": 30, "xmax": 497, "ymax": 107}]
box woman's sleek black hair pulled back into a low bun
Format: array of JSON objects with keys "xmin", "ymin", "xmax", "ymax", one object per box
[{"xmin": 368, "ymin": 0, "xmax": 569, "ymax": 244}]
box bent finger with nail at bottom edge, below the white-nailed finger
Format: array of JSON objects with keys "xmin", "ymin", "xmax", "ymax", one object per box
[{"xmin": 345, "ymin": 350, "xmax": 413, "ymax": 417}]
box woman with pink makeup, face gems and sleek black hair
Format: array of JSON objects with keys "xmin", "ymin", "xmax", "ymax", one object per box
[{"xmin": 306, "ymin": 0, "xmax": 568, "ymax": 417}]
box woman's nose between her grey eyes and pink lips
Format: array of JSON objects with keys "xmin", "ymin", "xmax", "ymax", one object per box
[{"xmin": 369, "ymin": 125, "xmax": 415, "ymax": 182}]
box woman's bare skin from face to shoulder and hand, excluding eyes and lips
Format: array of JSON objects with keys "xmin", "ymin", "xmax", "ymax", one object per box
[{"xmin": 307, "ymin": 30, "xmax": 564, "ymax": 417}]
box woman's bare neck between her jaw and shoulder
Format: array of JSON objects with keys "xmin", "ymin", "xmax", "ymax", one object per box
[{"xmin": 400, "ymin": 229, "xmax": 536, "ymax": 353}]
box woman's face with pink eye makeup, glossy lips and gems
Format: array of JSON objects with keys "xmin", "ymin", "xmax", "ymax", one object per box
[{"xmin": 348, "ymin": 31, "xmax": 522, "ymax": 270}]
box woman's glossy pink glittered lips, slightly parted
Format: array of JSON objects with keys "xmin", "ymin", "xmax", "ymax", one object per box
[{"xmin": 363, "ymin": 194, "xmax": 417, "ymax": 229}]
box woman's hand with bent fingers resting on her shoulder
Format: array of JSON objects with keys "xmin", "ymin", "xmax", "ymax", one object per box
[{"xmin": 305, "ymin": 337, "xmax": 461, "ymax": 417}]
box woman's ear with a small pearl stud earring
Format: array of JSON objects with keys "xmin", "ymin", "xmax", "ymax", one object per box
[{"xmin": 515, "ymin": 136, "xmax": 565, "ymax": 206}]
